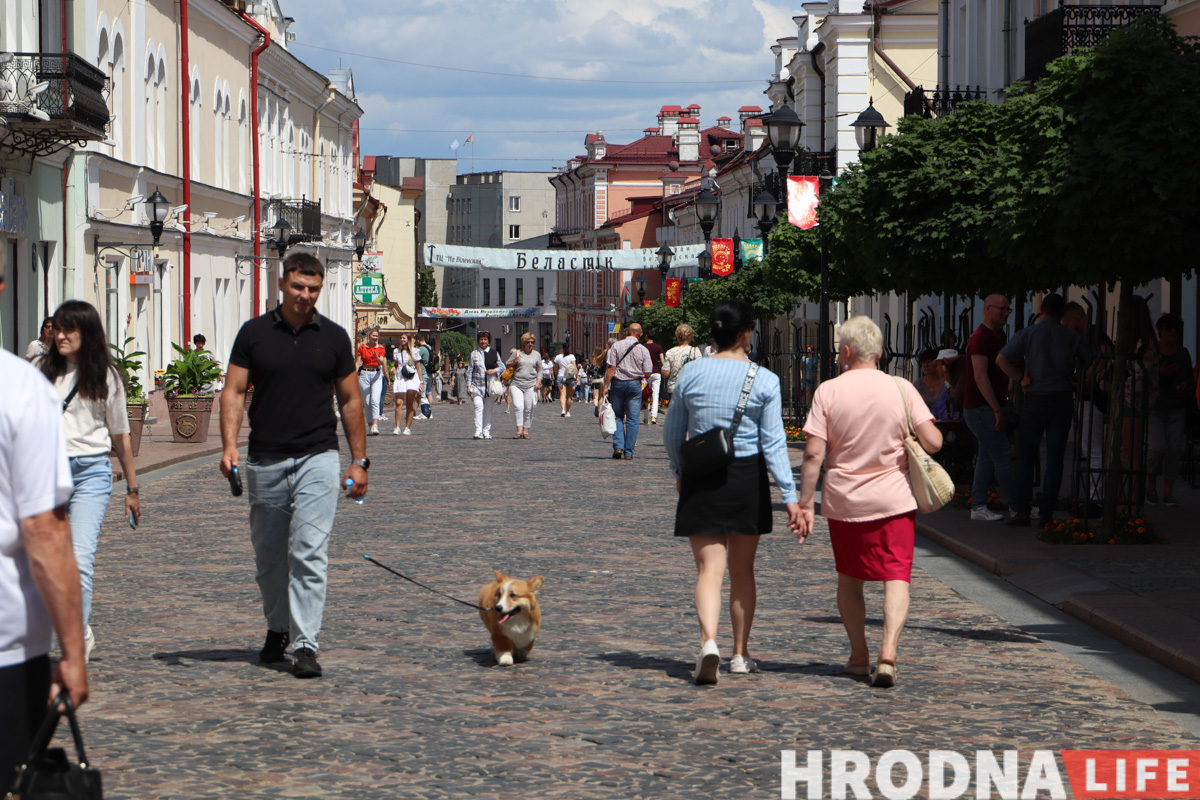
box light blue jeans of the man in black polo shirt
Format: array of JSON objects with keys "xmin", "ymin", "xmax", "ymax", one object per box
[{"xmin": 246, "ymin": 450, "xmax": 340, "ymax": 652}]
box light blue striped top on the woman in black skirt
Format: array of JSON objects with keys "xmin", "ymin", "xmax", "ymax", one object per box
[{"xmin": 662, "ymin": 359, "xmax": 796, "ymax": 503}]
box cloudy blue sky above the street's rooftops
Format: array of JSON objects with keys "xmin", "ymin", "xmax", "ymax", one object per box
[{"xmin": 280, "ymin": 0, "xmax": 799, "ymax": 173}]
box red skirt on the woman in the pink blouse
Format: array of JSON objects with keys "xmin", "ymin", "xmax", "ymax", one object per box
[{"xmin": 828, "ymin": 511, "xmax": 917, "ymax": 583}]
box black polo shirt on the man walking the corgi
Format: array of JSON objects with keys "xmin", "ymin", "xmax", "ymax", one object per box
[{"xmin": 229, "ymin": 308, "xmax": 354, "ymax": 458}]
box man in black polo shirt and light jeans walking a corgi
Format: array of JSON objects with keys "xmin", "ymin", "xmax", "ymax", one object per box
[{"xmin": 221, "ymin": 253, "xmax": 371, "ymax": 678}]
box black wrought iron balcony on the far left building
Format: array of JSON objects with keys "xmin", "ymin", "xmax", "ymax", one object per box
[{"xmin": 0, "ymin": 53, "xmax": 109, "ymax": 157}]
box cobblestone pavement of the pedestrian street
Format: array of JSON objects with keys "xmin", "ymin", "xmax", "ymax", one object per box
[{"xmin": 82, "ymin": 405, "xmax": 1196, "ymax": 799}]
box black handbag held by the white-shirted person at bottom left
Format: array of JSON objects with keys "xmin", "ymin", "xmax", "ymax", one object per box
[{"xmin": 8, "ymin": 692, "xmax": 104, "ymax": 800}]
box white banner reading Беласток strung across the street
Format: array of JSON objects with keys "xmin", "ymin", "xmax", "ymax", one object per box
[{"xmin": 425, "ymin": 245, "xmax": 704, "ymax": 272}]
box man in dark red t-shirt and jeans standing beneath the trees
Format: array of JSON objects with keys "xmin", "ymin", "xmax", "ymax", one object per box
[{"xmin": 962, "ymin": 294, "xmax": 1016, "ymax": 522}]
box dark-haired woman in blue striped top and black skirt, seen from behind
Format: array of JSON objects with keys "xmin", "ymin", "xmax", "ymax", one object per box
[{"xmin": 662, "ymin": 300, "xmax": 800, "ymax": 684}]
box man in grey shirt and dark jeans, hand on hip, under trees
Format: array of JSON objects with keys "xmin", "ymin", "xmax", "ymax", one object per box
[{"xmin": 996, "ymin": 294, "xmax": 1085, "ymax": 525}]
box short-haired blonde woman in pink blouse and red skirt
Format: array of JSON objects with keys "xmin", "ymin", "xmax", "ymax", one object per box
[{"xmin": 797, "ymin": 317, "xmax": 942, "ymax": 687}]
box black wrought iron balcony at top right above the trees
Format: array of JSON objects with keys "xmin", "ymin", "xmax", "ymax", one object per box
[{"xmin": 1025, "ymin": 5, "xmax": 1159, "ymax": 80}]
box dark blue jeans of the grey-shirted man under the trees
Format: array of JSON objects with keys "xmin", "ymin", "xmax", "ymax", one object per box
[{"xmin": 1016, "ymin": 392, "xmax": 1074, "ymax": 522}]
